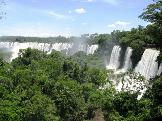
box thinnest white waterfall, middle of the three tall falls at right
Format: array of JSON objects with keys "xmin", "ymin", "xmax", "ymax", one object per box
[{"xmin": 123, "ymin": 47, "xmax": 133, "ymax": 71}]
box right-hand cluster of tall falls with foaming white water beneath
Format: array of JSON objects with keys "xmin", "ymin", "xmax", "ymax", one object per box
[{"xmin": 104, "ymin": 46, "xmax": 162, "ymax": 99}]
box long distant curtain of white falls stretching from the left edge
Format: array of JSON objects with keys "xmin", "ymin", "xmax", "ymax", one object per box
[{"xmin": 0, "ymin": 42, "xmax": 98, "ymax": 60}]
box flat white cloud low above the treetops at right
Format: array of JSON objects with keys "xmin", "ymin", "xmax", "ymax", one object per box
[{"xmin": 107, "ymin": 21, "xmax": 131, "ymax": 30}]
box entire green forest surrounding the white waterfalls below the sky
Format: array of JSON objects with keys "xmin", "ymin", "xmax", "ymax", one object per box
[{"xmin": 0, "ymin": 0, "xmax": 162, "ymax": 121}]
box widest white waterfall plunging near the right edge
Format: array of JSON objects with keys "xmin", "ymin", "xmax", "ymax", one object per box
[{"xmin": 135, "ymin": 49, "xmax": 160, "ymax": 79}]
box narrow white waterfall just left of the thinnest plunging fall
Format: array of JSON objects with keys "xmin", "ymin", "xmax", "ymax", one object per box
[{"xmin": 106, "ymin": 45, "xmax": 121, "ymax": 70}]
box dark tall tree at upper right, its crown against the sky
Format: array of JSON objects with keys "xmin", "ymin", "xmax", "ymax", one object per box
[{"xmin": 139, "ymin": 0, "xmax": 162, "ymax": 62}]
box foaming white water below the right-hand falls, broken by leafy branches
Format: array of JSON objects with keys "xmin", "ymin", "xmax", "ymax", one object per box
[{"xmin": 100, "ymin": 72, "xmax": 149, "ymax": 99}]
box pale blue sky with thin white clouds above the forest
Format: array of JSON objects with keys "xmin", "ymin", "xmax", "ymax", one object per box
[{"xmin": 0, "ymin": 0, "xmax": 152, "ymax": 37}]
